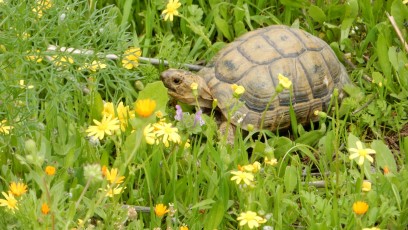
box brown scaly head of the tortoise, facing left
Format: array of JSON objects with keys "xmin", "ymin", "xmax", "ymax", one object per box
[{"xmin": 160, "ymin": 69, "xmax": 213, "ymax": 108}]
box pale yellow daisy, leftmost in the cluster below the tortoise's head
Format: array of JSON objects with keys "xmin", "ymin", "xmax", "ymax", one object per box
[{"xmin": 86, "ymin": 116, "xmax": 120, "ymax": 140}]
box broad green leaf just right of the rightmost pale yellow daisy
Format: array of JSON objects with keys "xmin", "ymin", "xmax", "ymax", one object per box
[{"xmin": 371, "ymin": 140, "xmax": 397, "ymax": 173}]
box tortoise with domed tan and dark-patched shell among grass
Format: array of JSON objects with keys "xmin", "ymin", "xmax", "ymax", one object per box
[{"xmin": 161, "ymin": 25, "xmax": 350, "ymax": 131}]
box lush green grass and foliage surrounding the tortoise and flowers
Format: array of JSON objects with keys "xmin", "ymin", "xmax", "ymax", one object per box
[{"xmin": 0, "ymin": 0, "xmax": 408, "ymax": 229}]
